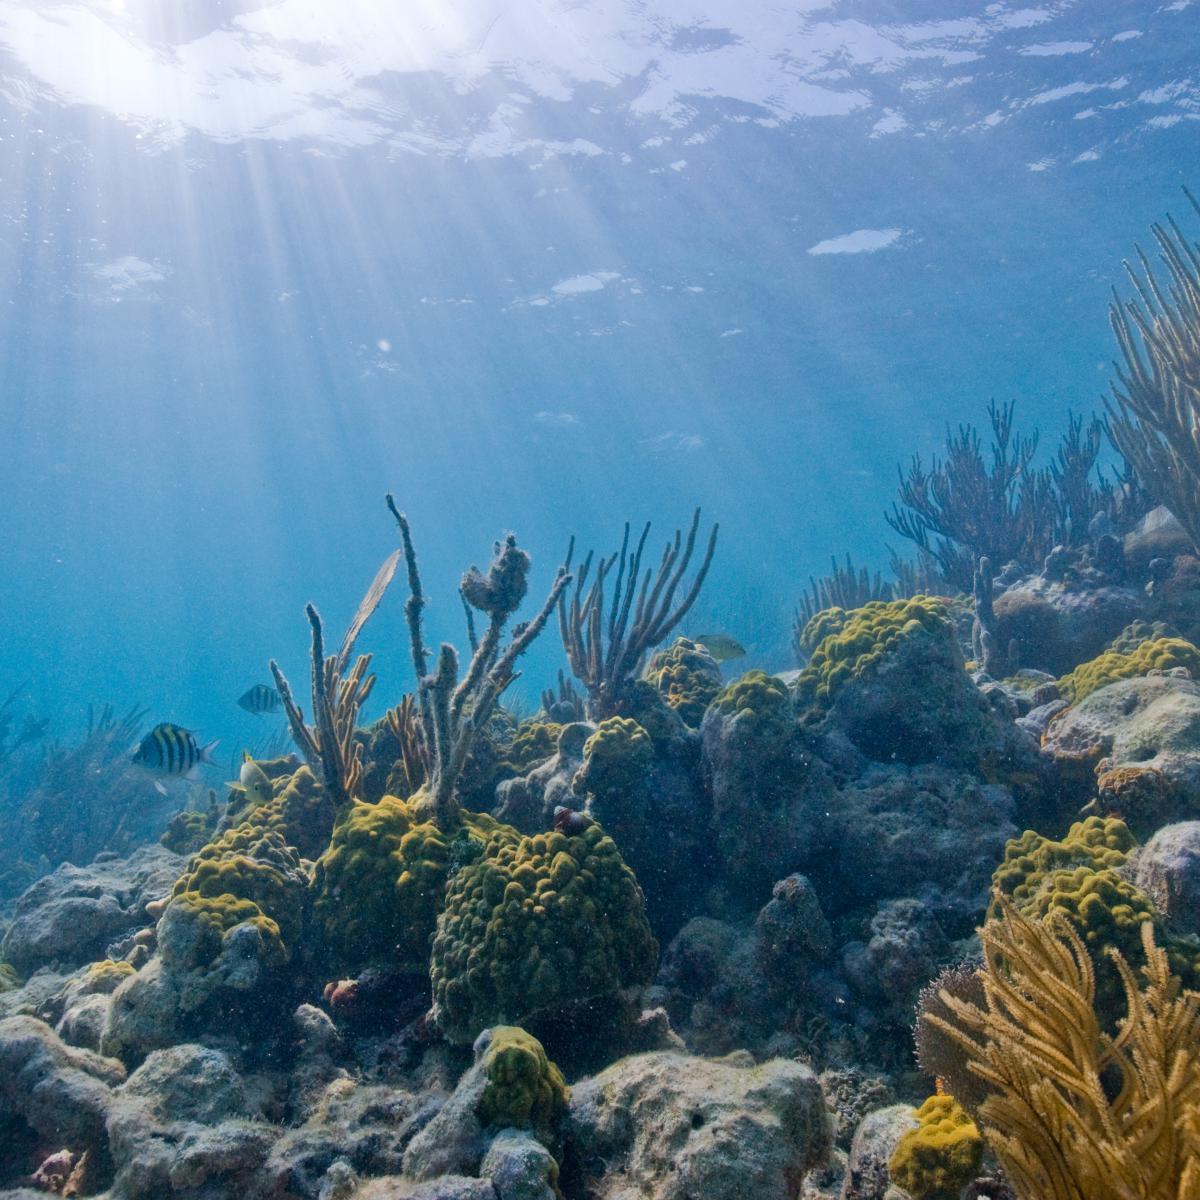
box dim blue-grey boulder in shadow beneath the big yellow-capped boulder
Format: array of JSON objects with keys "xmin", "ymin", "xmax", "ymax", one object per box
[{"xmin": 811, "ymin": 766, "xmax": 1018, "ymax": 926}]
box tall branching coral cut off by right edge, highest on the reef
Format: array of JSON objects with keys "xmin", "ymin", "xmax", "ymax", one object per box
[{"xmin": 1108, "ymin": 192, "xmax": 1200, "ymax": 550}]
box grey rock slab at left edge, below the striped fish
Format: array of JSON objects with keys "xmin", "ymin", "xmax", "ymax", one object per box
[{"xmin": 0, "ymin": 846, "xmax": 186, "ymax": 973}]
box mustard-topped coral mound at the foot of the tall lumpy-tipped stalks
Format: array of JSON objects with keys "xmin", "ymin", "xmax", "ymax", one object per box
[{"xmin": 313, "ymin": 796, "xmax": 518, "ymax": 970}]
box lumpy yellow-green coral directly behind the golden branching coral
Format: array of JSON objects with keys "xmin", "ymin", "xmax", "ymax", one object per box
[{"xmin": 991, "ymin": 817, "xmax": 1200, "ymax": 1025}]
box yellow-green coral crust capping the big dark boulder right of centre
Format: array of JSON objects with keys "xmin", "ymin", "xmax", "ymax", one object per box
[{"xmin": 796, "ymin": 596, "xmax": 954, "ymax": 708}]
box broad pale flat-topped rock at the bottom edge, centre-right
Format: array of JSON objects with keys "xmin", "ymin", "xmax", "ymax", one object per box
[{"xmin": 563, "ymin": 1051, "xmax": 829, "ymax": 1200}]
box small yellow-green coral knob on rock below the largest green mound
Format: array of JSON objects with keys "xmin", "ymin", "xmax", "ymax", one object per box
[{"xmin": 476, "ymin": 1025, "xmax": 566, "ymax": 1134}]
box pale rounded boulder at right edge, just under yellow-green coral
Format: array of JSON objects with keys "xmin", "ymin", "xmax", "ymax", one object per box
[{"xmin": 1042, "ymin": 676, "xmax": 1200, "ymax": 836}]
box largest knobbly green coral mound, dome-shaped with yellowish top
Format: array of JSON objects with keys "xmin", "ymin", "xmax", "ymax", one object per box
[{"xmin": 431, "ymin": 823, "xmax": 658, "ymax": 1043}]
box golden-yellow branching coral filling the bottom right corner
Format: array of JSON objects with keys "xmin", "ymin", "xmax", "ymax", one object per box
[{"xmin": 928, "ymin": 901, "xmax": 1200, "ymax": 1200}]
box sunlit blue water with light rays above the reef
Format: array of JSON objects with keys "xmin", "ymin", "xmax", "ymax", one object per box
[{"xmin": 0, "ymin": 0, "xmax": 1200, "ymax": 748}]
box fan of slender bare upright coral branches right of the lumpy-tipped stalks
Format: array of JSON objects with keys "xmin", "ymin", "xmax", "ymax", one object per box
[{"xmin": 558, "ymin": 509, "xmax": 719, "ymax": 720}]
